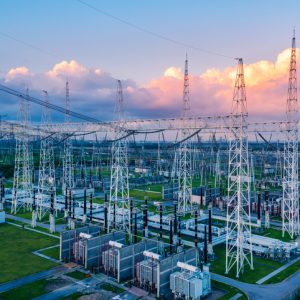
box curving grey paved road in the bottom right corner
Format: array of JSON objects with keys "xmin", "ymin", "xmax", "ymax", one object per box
[{"xmin": 211, "ymin": 271, "xmax": 300, "ymax": 300}]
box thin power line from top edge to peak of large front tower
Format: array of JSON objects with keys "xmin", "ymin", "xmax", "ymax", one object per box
[{"xmin": 77, "ymin": 0, "xmax": 234, "ymax": 59}]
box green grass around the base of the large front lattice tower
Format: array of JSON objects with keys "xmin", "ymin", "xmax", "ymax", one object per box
[{"xmin": 210, "ymin": 245, "xmax": 283, "ymax": 283}]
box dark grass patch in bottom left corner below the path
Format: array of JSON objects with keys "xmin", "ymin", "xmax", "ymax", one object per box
[{"xmin": 0, "ymin": 279, "xmax": 51, "ymax": 300}]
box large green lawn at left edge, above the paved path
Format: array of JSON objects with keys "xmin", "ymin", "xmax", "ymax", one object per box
[{"xmin": 0, "ymin": 224, "xmax": 57, "ymax": 283}]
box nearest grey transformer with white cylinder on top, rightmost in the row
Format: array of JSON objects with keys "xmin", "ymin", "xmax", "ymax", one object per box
[{"xmin": 170, "ymin": 262, "xmax": 211, "ymax": 300}]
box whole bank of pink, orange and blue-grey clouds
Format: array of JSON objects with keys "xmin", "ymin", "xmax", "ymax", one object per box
[{"xmin": 0, "ymin": 49, "xmax": 300, "ymax": 120}]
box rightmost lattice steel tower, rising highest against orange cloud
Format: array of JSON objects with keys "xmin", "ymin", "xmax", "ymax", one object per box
[{"xmin": 282, "ymin": 31, "xmax": 300, "ymax": 238}]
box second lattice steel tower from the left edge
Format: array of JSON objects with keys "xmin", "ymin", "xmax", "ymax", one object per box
[{"xmin": 37, "ymin": 91, "xmax": 56, "ymax": 220}]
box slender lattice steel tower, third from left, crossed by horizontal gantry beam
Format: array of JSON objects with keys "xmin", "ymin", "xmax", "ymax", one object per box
[{"xmin": 62, "ymin": 81, "xmax": 74, "ymax": 192}]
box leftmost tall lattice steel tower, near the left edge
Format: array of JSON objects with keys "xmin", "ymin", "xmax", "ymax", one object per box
[{"xmin": 11, "ymin": 90, "xmax": 33, "ymax": 214}]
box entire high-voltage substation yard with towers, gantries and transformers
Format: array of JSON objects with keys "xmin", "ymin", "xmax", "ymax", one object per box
[{"xmin": 0, "ymin": 32, "xmax": 300, "ymax": 299}]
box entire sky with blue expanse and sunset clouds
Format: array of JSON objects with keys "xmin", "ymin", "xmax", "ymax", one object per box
[{"xmin": 0, "ymin": 0, "xmax": 300, "ymax": 121}]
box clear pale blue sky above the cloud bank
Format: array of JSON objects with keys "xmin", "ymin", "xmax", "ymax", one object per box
[{"xmin": 0, "ymin": 0, "xmax": 300, "ymax": 83}]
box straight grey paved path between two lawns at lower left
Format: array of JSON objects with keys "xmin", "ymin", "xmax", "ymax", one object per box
[{"xmin": 0, "ymin": 266, "xmax": 68, "ymax": 293}]
